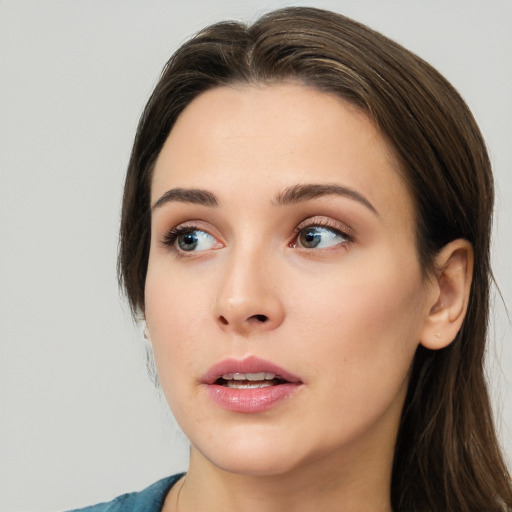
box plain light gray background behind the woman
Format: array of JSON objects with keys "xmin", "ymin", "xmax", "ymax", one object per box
[{"xmin": 0, "ymin": 0, "xmax": 512, "ymax": 512}]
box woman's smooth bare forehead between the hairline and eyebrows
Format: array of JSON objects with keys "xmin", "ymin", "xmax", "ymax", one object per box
[{"xmin": 152, "ymin": 83, "xmax": 413, "ymax": 233}]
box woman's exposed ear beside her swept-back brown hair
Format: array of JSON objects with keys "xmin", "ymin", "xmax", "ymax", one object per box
[{"xmin": 420, "ymin": 239, "xmax": 474, "ymax": 350}]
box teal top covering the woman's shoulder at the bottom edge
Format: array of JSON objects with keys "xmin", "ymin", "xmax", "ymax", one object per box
[{"xmin": 65, "ymin": 473, "xmax": 184, "ymax": 512}]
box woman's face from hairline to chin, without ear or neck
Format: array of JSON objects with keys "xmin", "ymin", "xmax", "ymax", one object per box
[{"xmin": 145, "ymin": 84, "xmax": 436, "ymax": 475}]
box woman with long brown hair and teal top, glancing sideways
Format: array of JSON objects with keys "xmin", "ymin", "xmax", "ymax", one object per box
[{"xmin": 73, "ymin": 8, "xmax": 512, "ymax": 512}]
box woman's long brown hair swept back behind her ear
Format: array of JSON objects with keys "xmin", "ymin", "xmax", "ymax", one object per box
[{"xmin": 119, "ymin": 8, "xmax": 512, "ymax": 512}]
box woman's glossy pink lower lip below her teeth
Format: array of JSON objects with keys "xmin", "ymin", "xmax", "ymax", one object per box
[{"xmin": 203, "ymin": 382, "xmax": 301, "ymax": 413}]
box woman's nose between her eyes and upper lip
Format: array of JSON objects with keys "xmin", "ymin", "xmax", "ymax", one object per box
[{"xmin": 212, "ymin": 248, "xmax": 285, "ymax": 336}]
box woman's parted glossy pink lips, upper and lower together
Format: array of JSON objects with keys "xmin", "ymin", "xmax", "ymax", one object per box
[{"xmin": 201, "ymin": 356, "xmax": 303, "ymax": 414}]
